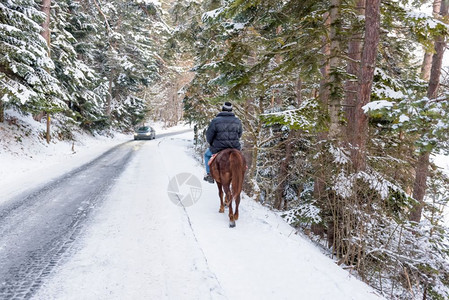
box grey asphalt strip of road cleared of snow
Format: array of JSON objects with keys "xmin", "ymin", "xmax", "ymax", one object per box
[{"xmin": 0, "ymin": 132, "xmax": 191, "ymax": 299}]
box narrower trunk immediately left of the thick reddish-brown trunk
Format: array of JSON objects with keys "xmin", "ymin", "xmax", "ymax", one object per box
[{"xmin": 344, "ymin": 0, "xmax": 365, "ymax": 141}]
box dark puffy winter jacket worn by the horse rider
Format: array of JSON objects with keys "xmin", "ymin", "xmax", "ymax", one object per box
[{"xmin": 206, "ymin": 111, "xmax": 242, "ymax": 154}]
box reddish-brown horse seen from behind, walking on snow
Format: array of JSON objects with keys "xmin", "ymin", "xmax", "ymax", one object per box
[{"xmin": 210, "ymin": 149, "xmax": 246, "ymax": 227}]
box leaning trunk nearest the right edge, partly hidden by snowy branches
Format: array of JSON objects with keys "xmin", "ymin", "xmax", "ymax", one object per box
[{"xmin": 409, "ymin": 0, "xmax": 449, "ymax": 222}]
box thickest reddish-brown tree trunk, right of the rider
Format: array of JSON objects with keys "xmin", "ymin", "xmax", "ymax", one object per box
[{"xmin": 352, "ymin": 0, "xmax": 380, "ymax": 172}]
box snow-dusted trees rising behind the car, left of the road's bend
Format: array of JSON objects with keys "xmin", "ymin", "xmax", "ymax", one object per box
[{"xmin": 90, "ymin": 1, "xmax": 169, "ymax": 127}]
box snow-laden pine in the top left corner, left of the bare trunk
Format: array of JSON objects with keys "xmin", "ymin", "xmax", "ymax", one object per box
[{"xmin": 0, "ymin": 0, "xmax": 64, "ymax": 120}]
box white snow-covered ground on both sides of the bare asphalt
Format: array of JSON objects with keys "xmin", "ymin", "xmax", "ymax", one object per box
[{"xmin": 0, "ymin": 118, "xmax": 381, "ymax": 300}]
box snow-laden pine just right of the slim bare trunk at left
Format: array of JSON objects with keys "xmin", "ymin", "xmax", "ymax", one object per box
[{"xmin": 51, "ymin": 0, "xmax": 105, "ymax": 129}]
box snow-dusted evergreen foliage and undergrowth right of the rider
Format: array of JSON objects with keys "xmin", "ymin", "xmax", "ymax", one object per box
[{"xmin": 183, "ymin": 0, "xmax": 449, "ymax": 299}]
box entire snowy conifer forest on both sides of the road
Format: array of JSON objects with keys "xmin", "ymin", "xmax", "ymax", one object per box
[{"xmin": 0, "ymin": 0, "xmax": 449, "ymax": 300}]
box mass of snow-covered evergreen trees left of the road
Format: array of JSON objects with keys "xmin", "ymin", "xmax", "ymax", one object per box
[{"xmin": 0, "ymin": 0, "xmax": 170, "ymax": 130}]
